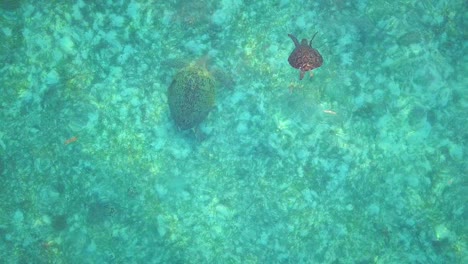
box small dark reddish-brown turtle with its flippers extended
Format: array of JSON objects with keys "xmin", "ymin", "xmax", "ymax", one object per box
[{"xmin": 288, "ymin": 33, "xmax": 323, "ymax": 80}]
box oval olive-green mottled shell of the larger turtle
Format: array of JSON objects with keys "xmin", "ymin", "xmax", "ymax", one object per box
[{"xmin": 167, "ymin": 64, "xmax": 216, "ymax": 130}]
